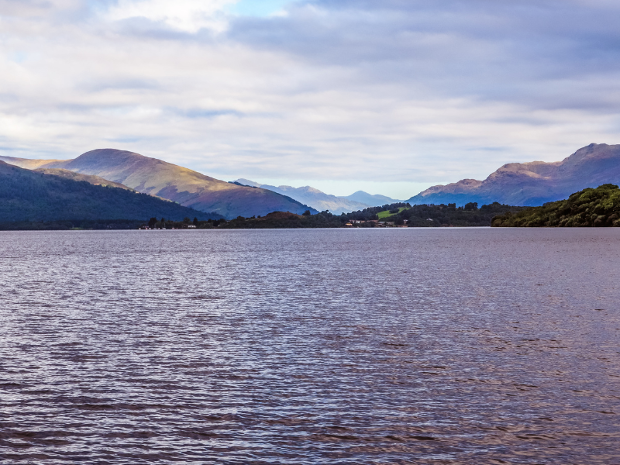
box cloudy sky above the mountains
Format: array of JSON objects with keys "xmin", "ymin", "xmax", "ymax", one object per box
[{"xmin": 0, "ymin": 0, "xmax": 620, "ymax": 199}]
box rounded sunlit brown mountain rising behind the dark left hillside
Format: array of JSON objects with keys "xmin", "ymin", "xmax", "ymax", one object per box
[{"xmin": 0, "ymin": 149, "xmax": 316, "ymax": 219}]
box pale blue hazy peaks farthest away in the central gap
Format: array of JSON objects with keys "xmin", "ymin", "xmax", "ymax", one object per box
[{"xmin": 234, "ymin": 178, "xmax": 398, "ymax": 215}]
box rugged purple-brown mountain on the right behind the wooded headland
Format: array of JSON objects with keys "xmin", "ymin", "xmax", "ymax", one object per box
[{"xmin": 407, "ymin": 144, "xmax": 620, "ymax": 206}]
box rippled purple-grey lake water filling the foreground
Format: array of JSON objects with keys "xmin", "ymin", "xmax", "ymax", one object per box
[{"xmin": 0, "ymin": 229, "xmax": 620, "ymax": 464}]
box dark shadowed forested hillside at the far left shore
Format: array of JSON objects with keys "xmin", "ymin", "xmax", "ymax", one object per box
[{"xmin": 0, "ymin": 161, "xmax": 221, "ymax": 223}]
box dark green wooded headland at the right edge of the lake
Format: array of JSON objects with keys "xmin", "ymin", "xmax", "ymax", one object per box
[{"xmin": 492, "ymin": 184, "xmax": 620, "ymax": 227}]
